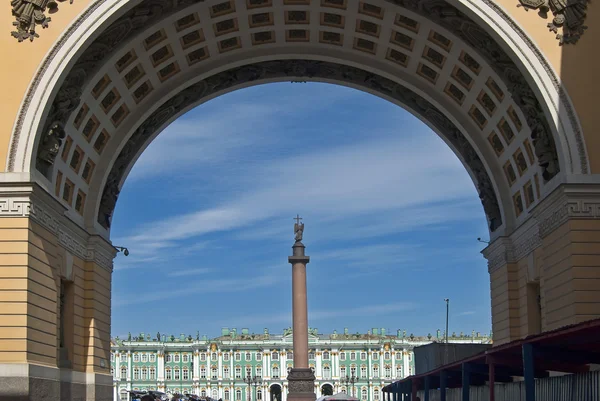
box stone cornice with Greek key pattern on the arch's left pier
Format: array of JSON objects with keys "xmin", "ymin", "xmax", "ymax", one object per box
[{"xmin": 0, "ymin": 183, "xmax": 116, "ymax": 272}]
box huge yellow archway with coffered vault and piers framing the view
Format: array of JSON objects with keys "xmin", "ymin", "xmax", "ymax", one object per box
[{"xmin": 0, "ymin": 0, "xmax": 600, "ymax": 400}]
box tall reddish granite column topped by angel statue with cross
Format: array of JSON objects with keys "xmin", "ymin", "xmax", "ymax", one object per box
[{"xmin": 288, "ymin": 215, "xmax": 315, "ymax": 401}]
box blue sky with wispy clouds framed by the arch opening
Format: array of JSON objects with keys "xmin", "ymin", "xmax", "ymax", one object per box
[{"xmin": 111, "ymin": 83, "xmax": 491, "ymax": 337}]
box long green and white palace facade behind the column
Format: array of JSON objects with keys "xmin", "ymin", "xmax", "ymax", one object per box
[{"xmin": 111, "ymin": 328, "xmax": 491, "ymax": 401}]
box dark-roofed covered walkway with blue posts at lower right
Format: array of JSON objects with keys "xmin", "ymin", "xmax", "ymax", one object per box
[{"xmin": 383, "ymin": 319, "xmax": 600, "ymax": 401}]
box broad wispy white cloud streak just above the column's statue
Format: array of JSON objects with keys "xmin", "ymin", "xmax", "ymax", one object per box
[{"xmin": 120, "ymin": 136, "xmax": 483, "ymax": 244}]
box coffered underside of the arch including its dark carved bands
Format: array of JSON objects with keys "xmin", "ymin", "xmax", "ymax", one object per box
[{"xmin": 15, "ymin": 0, "xmax": 585, "ymax": 241}]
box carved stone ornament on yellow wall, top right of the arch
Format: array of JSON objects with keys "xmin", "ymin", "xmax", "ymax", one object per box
[{"xmin": 519, "ymin": 0, "xmax": 589, "ymax": 45}]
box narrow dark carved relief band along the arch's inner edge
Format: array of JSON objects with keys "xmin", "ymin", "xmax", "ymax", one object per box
[{"xmin": 98, "ymin": 60, "xmax": 502, "ymax": 230}]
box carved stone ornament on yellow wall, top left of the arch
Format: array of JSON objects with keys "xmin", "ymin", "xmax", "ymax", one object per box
[{"xmin": 10, "ymin": 0, "xmax": 73, "ymax": 42}]
